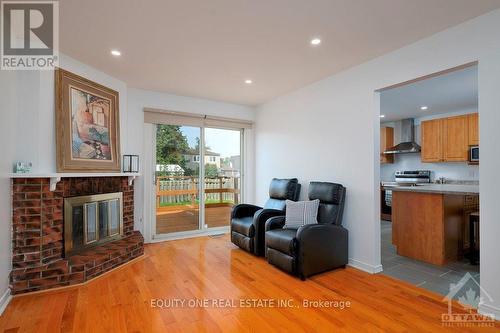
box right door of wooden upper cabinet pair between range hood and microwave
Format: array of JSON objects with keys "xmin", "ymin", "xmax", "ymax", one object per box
[{"xmin": 443, "ymin": 115, "xmax": 469, "ymax": 162}]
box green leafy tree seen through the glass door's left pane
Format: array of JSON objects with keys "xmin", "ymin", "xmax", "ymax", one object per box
[{"xmin": 156, "ymin": 125, "xmax": 189, "ymax": 170}]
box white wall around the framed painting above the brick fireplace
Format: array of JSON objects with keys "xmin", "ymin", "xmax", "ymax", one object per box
[{"xmin": 0, "ymin": 55, "xmax": 128, "ymax": 310}]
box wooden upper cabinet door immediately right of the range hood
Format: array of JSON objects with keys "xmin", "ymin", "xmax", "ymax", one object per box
[{"xmin": 420, "ymin": 119, "xmax": 444, "ymax": 162}]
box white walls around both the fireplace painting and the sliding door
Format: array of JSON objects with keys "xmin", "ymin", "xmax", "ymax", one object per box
[{"xmin": 0, "ymin": 54, "xmax": 255, "ymax": 306}]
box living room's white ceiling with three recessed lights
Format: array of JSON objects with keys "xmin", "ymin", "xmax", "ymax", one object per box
[{"xmin": 60, "ymin": 0, "xmax": 500, "ymax": 105}]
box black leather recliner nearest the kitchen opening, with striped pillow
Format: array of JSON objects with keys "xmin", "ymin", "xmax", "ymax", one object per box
[{"xmin": 265, "ymin": 182, "xmax": 348, "ymax": 280}]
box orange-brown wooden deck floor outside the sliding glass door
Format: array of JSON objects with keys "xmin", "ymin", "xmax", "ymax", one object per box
[{"xmin": 156, "ymin": 205, "xmax": 232, "ymax": 234}]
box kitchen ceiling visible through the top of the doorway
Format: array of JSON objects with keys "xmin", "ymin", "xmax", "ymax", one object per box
[{"xmin": 380, "ymin": 66, "xmax": 478, "ymax": 122}]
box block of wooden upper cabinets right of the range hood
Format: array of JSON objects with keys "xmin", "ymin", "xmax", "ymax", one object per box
[{"xmin": 421, "ymin": 113, "xmax": 479, "ymax": 163}]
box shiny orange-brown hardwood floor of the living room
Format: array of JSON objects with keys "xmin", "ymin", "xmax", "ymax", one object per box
[{"xmin": 0, "ymin": 235, "xmax": 498, "ymax": 332}]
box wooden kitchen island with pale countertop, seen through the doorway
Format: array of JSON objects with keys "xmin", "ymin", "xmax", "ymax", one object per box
[{"xmin": 385, "ymin": 184, "xmax": 479, "ymax": 265}]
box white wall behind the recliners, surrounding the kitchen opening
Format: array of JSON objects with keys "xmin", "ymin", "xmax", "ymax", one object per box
[{"xmin": 256, "ymin": 10, "xmax": 500, "ymax": 316}]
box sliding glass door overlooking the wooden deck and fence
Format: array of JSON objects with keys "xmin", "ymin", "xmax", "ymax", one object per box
[{"xmin": 154, "ymin": 124, "xmax": 243, "ymax": 235}]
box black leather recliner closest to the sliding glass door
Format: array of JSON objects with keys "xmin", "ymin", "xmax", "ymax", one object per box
[{"xmin": 231, "ymin": 178, "xmax": 300, "ymax": 256}]
